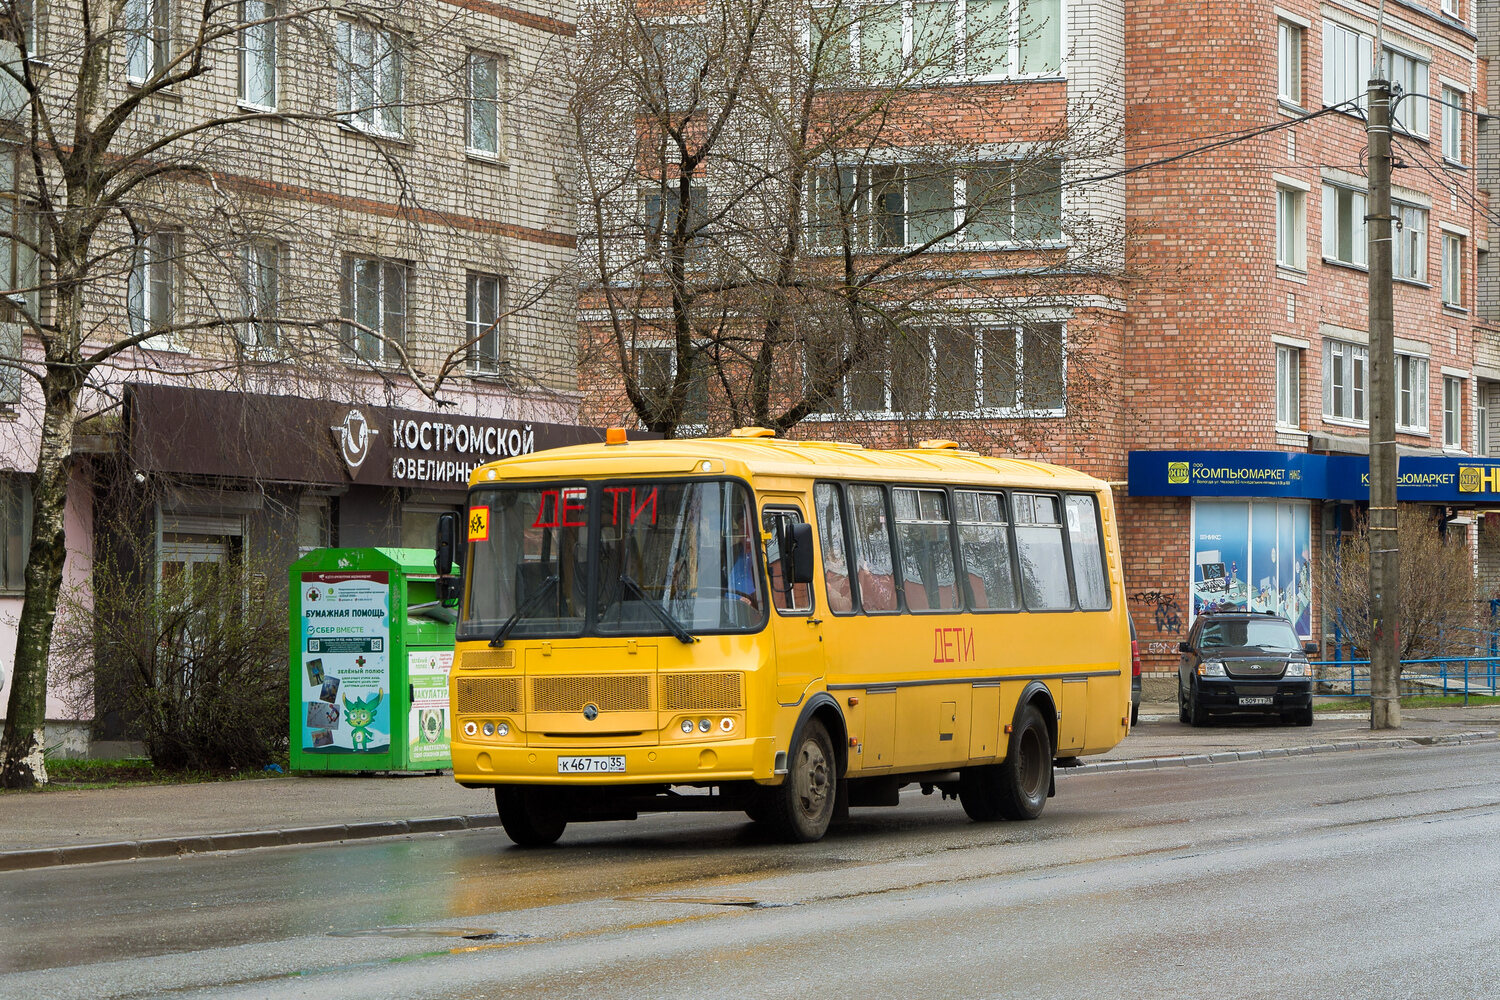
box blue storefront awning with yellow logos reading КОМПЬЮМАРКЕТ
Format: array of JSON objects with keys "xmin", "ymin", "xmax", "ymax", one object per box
[{"xmin": 1130, "ymin": 451, "xmax": 1500, "ymax": 505}]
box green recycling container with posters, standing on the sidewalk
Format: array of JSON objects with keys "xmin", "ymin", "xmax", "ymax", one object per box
[{"xmin": 288, "ymin": 549, "xmax": 455, "ymax": 771}]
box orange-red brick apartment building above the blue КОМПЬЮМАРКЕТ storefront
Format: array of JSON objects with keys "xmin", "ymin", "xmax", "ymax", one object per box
[{"xmin": 582, "ymin": 0, "xmax": 1500, "ymax": 670}]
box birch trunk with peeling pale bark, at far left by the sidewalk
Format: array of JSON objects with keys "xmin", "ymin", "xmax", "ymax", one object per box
[{"xmin": 0, "ymin": 369, "xmax": 81, "ymax": 789}]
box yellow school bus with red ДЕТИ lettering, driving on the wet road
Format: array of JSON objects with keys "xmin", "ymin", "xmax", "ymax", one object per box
[{"xmin": 440, "ymin": 429, "xmax": 1131, "ymax": 846}]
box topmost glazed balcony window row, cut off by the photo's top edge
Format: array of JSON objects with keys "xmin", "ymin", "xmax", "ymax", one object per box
[{"xmin": 809, "ymin": 0, "xmax": 1065, "ymax": 79}]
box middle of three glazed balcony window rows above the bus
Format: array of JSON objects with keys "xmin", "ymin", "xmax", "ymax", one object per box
[{"xmin": 810, "ymin": 160, "xmax": 1062, "ymax": 249}]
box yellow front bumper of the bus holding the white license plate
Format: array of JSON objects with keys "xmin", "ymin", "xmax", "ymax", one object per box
[{"xmin": 453, "ymin": 738, "xmax": 776, "ymax": 786}]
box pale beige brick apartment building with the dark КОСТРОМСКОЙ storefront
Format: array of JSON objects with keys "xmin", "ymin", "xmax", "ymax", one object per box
[{"xmin": 0, "ymin": 0, "xmax": 587, "ymax": 749}]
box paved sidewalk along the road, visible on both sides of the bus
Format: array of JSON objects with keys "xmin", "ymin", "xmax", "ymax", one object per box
[{"xmin": 0, "ymin": 703, "xmax": 1500, "ymax": 871}]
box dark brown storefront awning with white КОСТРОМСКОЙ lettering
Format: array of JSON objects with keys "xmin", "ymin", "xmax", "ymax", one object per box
[{"xmin": 126, "ymin": 385, "xmax": 605, "ymax": 490}]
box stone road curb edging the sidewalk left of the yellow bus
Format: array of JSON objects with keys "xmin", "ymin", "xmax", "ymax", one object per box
[{"xmin": 0, "ymin": 813, "xmax": 500, "ymax": 871}]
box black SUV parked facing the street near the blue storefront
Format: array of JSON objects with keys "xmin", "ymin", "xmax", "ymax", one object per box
[{"xmin": 1178, "ymin": 612, "xmax": 1317, "ymax": 726}]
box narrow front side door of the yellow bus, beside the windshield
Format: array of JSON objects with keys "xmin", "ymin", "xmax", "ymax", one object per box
[{"xmin": 761, "ymin": 502, "xmax": 824, "ymax": 706}]
